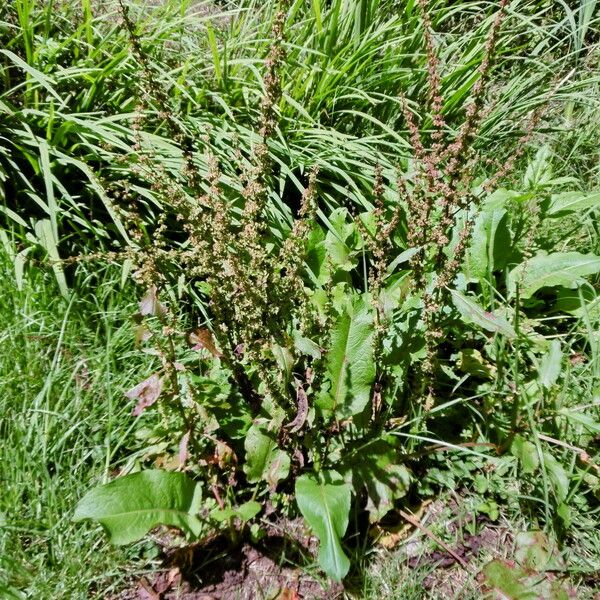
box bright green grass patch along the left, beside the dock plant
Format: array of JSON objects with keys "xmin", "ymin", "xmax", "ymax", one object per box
[{"xmin": 0, "ymin": 251, "xmax": 148, "ymax": 599}]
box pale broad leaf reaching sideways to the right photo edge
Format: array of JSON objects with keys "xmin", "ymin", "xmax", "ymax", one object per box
[{"xmin": 508, "ymin": 252, "xmax": 600, "ymax": 299}]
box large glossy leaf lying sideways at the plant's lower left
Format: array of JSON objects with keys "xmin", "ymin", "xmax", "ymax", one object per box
[{"xmin": 73, "ymin": 470, "xmax": 202, "ymax": 544}]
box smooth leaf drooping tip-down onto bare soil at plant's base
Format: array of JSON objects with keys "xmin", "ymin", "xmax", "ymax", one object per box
[{"xmin": 296, "ymin": 473, "xmax": 351, "ymax": 581}]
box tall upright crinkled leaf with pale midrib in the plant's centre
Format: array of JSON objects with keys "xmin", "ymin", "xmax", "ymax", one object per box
[{"xmin": 318, "ymin": 298, "xmax": 375, "ymax": 419}]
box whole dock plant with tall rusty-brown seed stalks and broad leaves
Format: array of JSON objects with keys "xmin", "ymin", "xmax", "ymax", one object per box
[{"xmin": 70, "ymin": 0, "xmax": 600, "ymax": 580}]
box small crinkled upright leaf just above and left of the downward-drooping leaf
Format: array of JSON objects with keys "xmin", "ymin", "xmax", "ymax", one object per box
[{"xmin": 244, "ymin": 425, "xmax": 290, "ymax": 488}]
